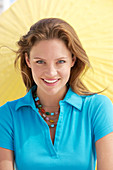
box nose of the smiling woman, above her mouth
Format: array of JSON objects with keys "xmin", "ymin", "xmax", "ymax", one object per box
[{"xmin": 45, "ymin": 64, "xmax": 57, "ymax": 77}]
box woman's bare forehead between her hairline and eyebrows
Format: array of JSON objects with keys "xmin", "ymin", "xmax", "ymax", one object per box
[{"xmin": 30, "ymin": 39, "xmax": 71, "ymax": 56}]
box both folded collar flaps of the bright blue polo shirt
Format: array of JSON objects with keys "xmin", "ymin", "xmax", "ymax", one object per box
[{"xmin": 16, "ymin": 86, "xmax": 83, "ymax": 110}]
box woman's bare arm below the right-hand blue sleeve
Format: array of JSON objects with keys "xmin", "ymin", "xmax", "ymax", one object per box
[{"xmin": 96, "ymin": 132, "xmax": 113, "ymax": 170}]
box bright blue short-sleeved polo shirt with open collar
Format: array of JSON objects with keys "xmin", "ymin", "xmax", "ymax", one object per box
[{"xmin": 0, "ymin": 88, "xmax": 113, "ymax": 170}]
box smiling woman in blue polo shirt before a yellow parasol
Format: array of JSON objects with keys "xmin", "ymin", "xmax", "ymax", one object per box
[{"xmin": 0, "ymin": 18, "xmax": 113, "ymax": 170}]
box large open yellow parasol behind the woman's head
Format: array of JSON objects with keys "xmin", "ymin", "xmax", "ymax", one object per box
[{"xmin": 0, "ymin": 0, "xmax": 113, "ymax": 105}]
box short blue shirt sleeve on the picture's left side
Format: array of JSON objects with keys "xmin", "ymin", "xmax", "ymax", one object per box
[{"xmin": 0, "ymin": 103, "xmax": 14, "ymax": 150}]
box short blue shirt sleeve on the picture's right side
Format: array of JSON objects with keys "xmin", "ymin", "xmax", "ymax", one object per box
[{"xmin": 90, "ymin": 95, "xmax": 113, "ymax": 142}]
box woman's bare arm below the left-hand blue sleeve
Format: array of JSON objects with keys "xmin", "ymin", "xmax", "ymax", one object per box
[{"xmin": 0, "ymin": 147, "xmax": 14, "ymax": 170}]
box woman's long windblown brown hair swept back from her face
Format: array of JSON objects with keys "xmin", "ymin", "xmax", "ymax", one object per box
[{"xmin": 15, "ymin": 18, "xmax": 92, "ymax": 95}]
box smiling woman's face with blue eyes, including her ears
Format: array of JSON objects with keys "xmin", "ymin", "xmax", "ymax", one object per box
[{"xmin": 26, "ymin": 39, "xmax": 75, "ymax": 95}]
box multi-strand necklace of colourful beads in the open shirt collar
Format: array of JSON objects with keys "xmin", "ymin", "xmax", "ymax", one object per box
[{"xmin": 33, "ymin": 92, "xmax": 60, "ymax": 128}]
